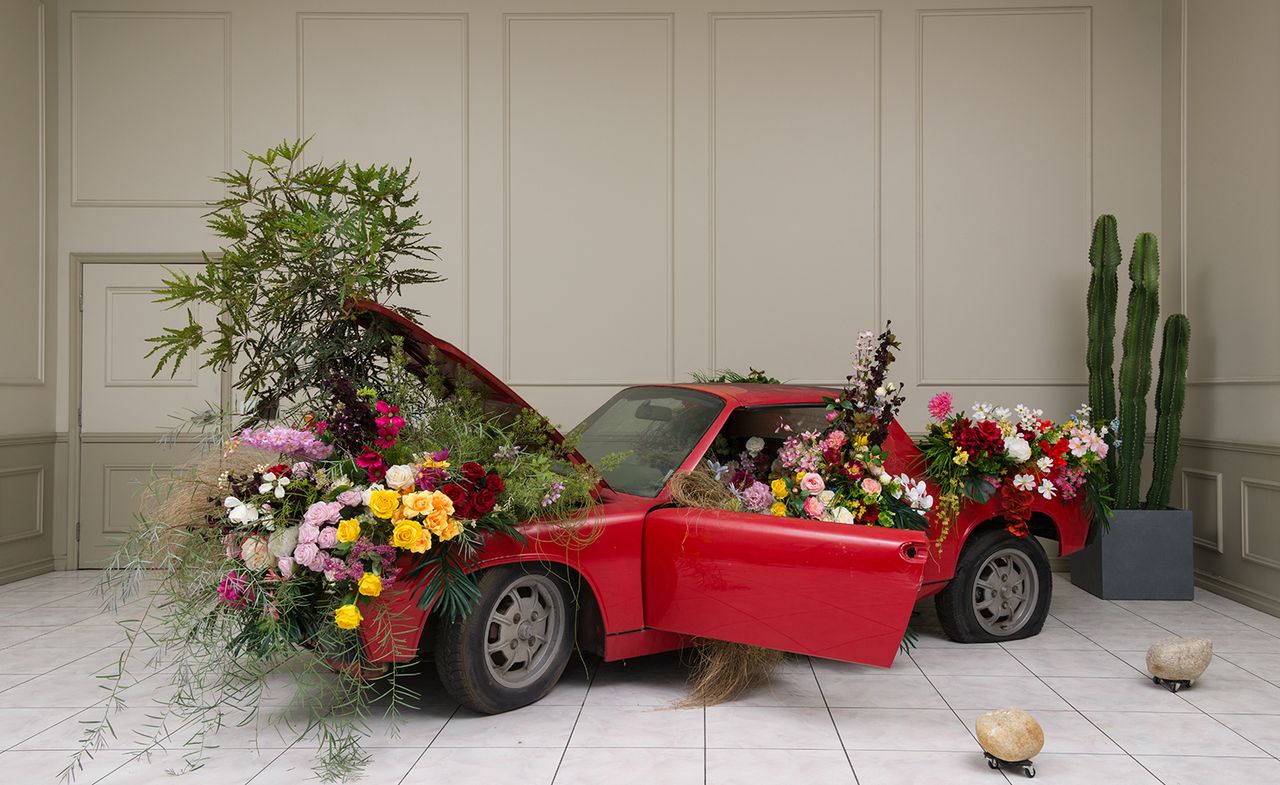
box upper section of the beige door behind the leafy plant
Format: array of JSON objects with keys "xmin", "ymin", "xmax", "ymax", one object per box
[{"xmin": 81, "ymin": 264, "xmax": 221, "ymax": 433}]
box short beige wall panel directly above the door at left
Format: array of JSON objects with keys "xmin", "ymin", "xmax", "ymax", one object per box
[{"xmin": 70, "ymin": 12, "xmax": 230, "ymax": 206}]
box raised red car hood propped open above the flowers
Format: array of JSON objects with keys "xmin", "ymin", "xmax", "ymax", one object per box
[{"xmin": 351, "ymin": 300, "xmax": 591, "ymax": 468}]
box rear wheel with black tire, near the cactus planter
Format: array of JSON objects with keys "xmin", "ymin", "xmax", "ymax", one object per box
[{"xmin": 934, "ymin": 528, "xmax": 1053, "ymax": 643}]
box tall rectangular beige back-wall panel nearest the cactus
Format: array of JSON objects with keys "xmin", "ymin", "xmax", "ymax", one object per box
[{"xmin": 916, "ymin": 9, "xmax": 1092, "ymax": 385}]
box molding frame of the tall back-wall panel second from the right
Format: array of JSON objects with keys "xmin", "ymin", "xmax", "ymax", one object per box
[{"xmin": 711, "ymin": 10, "xmax": 883, "ymax": 387}]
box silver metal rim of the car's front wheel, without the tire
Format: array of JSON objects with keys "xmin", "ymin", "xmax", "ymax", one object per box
[{"xmin": 484, "ymin": 575, "xmax": 564, "ymax": 688}]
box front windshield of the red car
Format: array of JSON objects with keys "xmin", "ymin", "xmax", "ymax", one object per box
[{"xmin": 573, "ymin": 387, "xmax": 724, "ymax": 498}]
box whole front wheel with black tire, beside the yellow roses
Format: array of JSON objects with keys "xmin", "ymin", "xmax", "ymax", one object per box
[{"xmin": 435, "ymin": 565, "xmax": 576, "ymax": 715}]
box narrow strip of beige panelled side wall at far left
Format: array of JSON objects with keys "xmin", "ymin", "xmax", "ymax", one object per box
[{"xmin": 0, "ymin": 0, "xmax": 58, "ymax": 583}]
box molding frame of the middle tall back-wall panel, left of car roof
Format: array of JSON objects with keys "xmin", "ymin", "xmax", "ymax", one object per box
[{"xmin": 500, "ymin": 12, "xmax": 676, "ymax": 387}]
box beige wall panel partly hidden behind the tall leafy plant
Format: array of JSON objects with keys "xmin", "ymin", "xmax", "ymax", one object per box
[{"xmin": 298, "ymin": 13, "xmax": 467, "ymax": 346}]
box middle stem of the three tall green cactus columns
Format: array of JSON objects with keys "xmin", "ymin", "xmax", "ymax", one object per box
[{"xmin": 1115, "ymin": 232, "xmax": 1160, "ymax": 510}]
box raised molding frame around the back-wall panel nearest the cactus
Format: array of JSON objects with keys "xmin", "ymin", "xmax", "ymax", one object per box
[{"xmin": 915, "ymin": 6, "xmax": 1094, "ymax": 387}]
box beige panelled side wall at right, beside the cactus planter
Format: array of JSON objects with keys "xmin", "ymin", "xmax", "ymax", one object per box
[{"xmin": 1161, "ymin": 0, "xmax": 1280, "ymax": 613}]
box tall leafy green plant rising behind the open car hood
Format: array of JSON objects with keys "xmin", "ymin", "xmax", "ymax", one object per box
[{"xmin": 148, "ymin": 141, "xmax": 442, "ymax": 423}]
